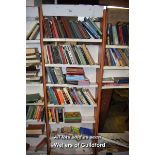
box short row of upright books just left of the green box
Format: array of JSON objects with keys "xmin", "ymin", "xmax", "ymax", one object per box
[{"xmin": 48, "ymin": 108, "xmax": 64, "ymax": 123}]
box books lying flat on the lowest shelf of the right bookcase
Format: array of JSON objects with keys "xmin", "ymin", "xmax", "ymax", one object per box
[{"xmin": 103, "ymin": 77, "xmax": 129, "ymax": 86}]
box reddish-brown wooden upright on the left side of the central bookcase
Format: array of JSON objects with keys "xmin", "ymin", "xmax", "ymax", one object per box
[{"xmin": 38, "ymin": 4, "xmax": 50, "ymax": 155}]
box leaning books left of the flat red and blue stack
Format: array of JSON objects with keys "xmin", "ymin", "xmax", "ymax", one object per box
[{"xmin": 46, "ymin": 67, "xmax": 65, "ymax": 84}]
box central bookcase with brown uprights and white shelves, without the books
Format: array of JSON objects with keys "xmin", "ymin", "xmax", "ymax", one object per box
[{"xmin": 39, "ymin": 5, "xmax": 105, "ymax": 154}]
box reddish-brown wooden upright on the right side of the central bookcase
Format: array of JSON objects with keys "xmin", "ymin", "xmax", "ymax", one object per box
[{"xmin": 95, "ymin": 9, "xmax": 107, "ymax": 135}]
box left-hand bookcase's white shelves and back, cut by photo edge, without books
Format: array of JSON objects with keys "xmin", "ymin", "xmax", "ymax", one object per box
[{"xmin": 26, "ymin": 6, "xmax": 47, "ymax": 155}]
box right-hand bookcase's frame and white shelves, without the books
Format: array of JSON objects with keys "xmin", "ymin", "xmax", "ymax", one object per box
[{"xmin": 98, "ymin": 7, "xmax": 129, "ymax": 154}]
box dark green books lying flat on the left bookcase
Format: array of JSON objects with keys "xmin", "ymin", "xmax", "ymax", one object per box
[{"xmin": 26, "ymin": 93, "xmax": 43, "ymax": 104}]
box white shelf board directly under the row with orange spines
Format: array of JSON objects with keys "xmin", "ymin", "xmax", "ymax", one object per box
[{"xmin": 48, "ymin": 104, "xmax": 97, "ymax": 108}]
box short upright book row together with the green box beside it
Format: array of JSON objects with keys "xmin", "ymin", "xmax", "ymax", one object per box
[{"xmin": 48, "ymin": 108, "xmax": 82, "ymax": 123}]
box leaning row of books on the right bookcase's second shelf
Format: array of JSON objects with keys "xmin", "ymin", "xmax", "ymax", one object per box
[{"xmin": 105, "ymin": 48, "xmax": 129, "ymax": 66}]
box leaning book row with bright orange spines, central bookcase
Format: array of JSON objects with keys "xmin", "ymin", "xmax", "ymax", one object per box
[{"xmin": 47, "ymin": 87, "xmax": 95, "ymax": 105}]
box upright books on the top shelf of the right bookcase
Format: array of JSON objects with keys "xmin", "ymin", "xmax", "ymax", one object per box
[{"xmin": 107, "ymin": 22, "xmax": 129, "ymax": 45}]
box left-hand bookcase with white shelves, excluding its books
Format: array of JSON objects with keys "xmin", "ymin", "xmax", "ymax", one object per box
[{"xmin": 26, "ymin": 6, "xmax": 47, "ymax": 154}]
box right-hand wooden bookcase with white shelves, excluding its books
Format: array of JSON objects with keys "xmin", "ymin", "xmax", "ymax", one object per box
[{"xmin": 98, "ymin": 7, "xmax": 129, "ymax": 154}]
